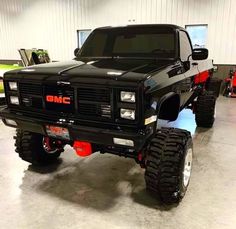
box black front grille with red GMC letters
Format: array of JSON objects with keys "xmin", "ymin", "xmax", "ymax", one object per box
[{"xmin": 15, "ymin": 82, "xmax": 113, "ymax": 120}]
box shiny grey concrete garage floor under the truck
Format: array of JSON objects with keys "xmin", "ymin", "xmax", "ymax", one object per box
[{"xmin": 0, "ymin": 97, "xmax": 236, "ymax": 229}]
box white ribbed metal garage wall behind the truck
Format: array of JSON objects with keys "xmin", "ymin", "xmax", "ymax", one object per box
[{"xmin": 0, "ymin": 0, "xmax": 236, "ymax": 64}]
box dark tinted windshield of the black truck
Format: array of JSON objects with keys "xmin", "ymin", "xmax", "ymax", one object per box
[{"xmin": 78, "ymin": 27, "xmax": 176, "ymax": 58}]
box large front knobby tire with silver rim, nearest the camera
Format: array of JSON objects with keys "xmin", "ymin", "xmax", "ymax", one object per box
[{"xmin": 145, "ymin": 128, "xmax": 193, "ymax": 204}]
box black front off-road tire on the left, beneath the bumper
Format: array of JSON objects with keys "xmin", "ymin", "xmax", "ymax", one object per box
[{"xmin": 14, "ymin": 129, "xmax": 64, "ymax": 165}]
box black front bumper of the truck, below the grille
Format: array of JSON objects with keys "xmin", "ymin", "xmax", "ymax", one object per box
[{"xmin": 0, "ymin": 108, "xmax": 152, "ymax": 152}]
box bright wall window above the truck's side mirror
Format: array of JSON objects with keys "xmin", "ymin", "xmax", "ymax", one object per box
[{"xmin": 185, "ymin": 25, "xmax": 207, "ymax": 48}]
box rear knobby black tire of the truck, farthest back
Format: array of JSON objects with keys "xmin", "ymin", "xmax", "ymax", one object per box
[{"xmin": 195, "ymin": 91, "xmax": 216, "ymax": 128}]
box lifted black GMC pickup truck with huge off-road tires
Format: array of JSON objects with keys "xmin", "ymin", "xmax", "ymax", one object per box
[{"xmin": 0, "ymin": 24, "xmax": 219, "ymax": 203}]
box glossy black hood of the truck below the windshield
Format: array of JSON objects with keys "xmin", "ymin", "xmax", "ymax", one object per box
[{"xmin": 5, "ymin": 59, "xmax": 173, "ymax": 82}]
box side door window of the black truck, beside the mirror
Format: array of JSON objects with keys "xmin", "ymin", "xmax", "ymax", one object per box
[{"xmin": 179, "ymin": 31, "xmax": 192, "ymax": 61}]
